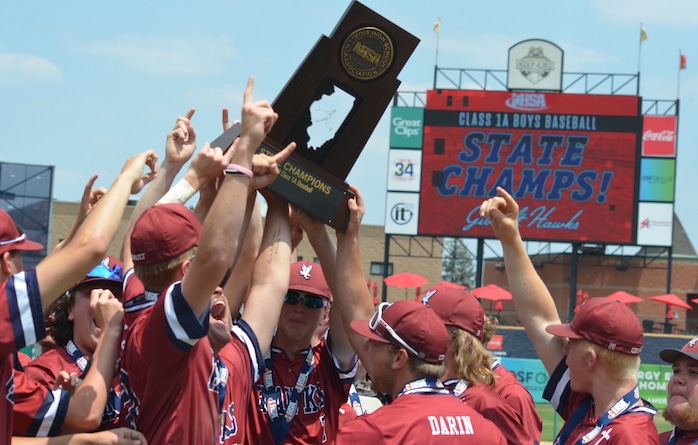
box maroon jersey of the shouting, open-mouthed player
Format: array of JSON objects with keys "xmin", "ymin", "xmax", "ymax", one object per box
[{"xmin": 217, "ymin": 320, "xmax": 264, "ymax": 445}]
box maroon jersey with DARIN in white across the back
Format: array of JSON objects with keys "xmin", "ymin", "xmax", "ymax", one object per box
[{"xmin": 335, "ymin": 380, "xmax": 507, "ymax": 445}]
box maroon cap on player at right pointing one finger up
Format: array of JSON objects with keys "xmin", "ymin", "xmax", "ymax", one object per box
[{"xmin": 545, "ymin": 298, "xmax": 643, "ymax": 355}]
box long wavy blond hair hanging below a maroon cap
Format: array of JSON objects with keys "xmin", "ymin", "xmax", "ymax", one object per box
[{"xmin": 448, "ymin": 326, "xmax": 496, "ymax": 388}]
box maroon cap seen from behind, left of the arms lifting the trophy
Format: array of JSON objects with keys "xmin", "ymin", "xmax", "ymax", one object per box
[{"xmin": 131, "ymin": 203, "xmax": 201, "ymax": 264}]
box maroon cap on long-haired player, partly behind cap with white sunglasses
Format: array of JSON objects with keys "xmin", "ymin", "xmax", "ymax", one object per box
[{"xmin": 422, "ymin": 284, "xmax": 485, "ymax": 341}]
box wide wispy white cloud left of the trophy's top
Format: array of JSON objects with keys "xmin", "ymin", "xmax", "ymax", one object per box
[{"xmin": 82, "ymin": 36, "xmax": 236, "ymax": 75}]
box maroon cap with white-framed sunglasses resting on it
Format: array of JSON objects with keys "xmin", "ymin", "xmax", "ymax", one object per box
[{"xmin": 351, "ymin": 300, "xmax": 449, "ymax": 364}]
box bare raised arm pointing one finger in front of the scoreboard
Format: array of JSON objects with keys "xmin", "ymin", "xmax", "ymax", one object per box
[{"xmin": 480, "ymin": 187, "xmax": 567, "ymax": 373}]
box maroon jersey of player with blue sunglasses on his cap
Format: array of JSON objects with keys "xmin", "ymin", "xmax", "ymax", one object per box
[{"xmin": 24, "ymin": 341, "xmax": 120, "ymax": 430}]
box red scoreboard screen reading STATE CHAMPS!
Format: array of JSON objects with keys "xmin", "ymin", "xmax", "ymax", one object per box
[{"xmin": 419, "ymin": 90, "xmax": 642, "ymax": 244}]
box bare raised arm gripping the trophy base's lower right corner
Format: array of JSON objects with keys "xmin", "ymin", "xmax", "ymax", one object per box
[{"xmin": 334, "ymin": 186, "xmax": 374, "ymax": 374}]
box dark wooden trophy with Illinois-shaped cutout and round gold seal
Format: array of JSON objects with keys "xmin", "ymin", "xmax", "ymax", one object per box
[{"xmin": 258, "ymin": 1, "xmax": 419, "ymax": 233}]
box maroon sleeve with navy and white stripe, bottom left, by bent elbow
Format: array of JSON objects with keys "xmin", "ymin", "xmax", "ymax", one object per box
[{"xmin": 12, "ymin": 371, "xmax": 70, "ymax": 437}]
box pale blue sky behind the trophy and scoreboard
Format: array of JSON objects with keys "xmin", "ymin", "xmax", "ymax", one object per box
[{"xmin": 0, "ymin": 0, "xmax": 698, "ymax": 248}]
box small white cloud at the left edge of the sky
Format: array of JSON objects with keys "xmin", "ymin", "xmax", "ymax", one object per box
[{"xmin": 0, "ymin": 53, "xmax": 62, "ymax": 85}]
